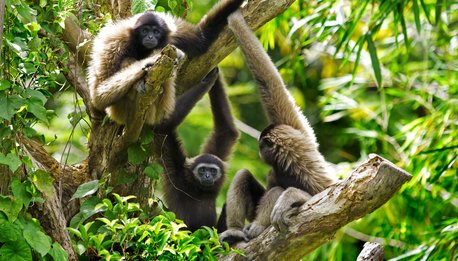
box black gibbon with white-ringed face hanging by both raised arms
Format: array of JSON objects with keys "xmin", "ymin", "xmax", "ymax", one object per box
[{"xmin": 153, "ymin": 69, "xmax": 239, "ymax": 231}]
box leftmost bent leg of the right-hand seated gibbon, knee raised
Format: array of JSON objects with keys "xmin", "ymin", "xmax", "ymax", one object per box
[{"xmin": 219, "ymin": 169, "xmax": 265, "ymax": 244}]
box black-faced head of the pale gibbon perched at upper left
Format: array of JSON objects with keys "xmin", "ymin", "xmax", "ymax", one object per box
[{"xmin": 134, "ymin": 13, "xmax": 169, "ymax": 50}]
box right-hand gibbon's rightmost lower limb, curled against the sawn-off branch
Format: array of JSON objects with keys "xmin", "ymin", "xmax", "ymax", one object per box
[{"xmin": 270, "ymin": 187, "xmax": 312, "ymax": 231}]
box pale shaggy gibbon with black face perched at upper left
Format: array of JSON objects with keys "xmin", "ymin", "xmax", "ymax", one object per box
[{"xmin": 87, "ymin": 0, "xmax": 244, "ymax": 125}]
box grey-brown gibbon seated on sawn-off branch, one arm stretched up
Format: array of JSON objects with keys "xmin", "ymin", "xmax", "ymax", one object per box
[{"xmin": 220, "ymin": 11, "xmax": 336, "ymax": 244}]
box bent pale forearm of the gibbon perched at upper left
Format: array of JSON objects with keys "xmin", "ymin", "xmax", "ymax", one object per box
[{"xmin": 91, "ymin": 57, "xmax": 157, "ymax": 111}]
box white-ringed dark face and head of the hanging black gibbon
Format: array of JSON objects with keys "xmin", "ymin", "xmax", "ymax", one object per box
[{"xmin": 191, "ymin": 154, "xmax": 224, "ymax": 189}]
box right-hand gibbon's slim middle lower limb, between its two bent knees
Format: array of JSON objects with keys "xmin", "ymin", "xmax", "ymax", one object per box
[{"xmin": 243, "ymin": 187, "xmax": 285, "ymax": 239}]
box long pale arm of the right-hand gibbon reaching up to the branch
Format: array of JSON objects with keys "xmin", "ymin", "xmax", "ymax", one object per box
[{"xmin": 228, "ymin": 11, "xmax": 314, "ymax": 137}]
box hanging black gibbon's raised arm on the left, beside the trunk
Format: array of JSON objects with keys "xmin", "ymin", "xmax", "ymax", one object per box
[{"xmin": 153, "ymin": 68, "xmax": 218, "ymax": 173}]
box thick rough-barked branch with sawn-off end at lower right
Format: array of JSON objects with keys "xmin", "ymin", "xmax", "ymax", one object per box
[{"xmin": 222, "ymin": 155, "xmax": 412, "ymax": 260}]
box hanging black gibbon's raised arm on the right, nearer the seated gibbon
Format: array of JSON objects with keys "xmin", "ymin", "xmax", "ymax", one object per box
[{"xmin": 202, "ymin": 71, "xmax": 239, "ymax": 161}]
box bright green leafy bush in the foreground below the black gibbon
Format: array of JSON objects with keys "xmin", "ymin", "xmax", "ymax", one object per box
[{"xmin": 69, "ymin": 191, "xmax": 242, "ymax": 260}]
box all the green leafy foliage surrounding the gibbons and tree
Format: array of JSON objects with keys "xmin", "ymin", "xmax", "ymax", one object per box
[{"xmin": 0, "ymin": 0, "xmax": 458, "ymax": 260}]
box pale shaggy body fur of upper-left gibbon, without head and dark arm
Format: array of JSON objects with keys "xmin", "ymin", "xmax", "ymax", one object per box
[{"xmin": 88, "ymin": 14, "xmax": 175, "ymax": 124}]
